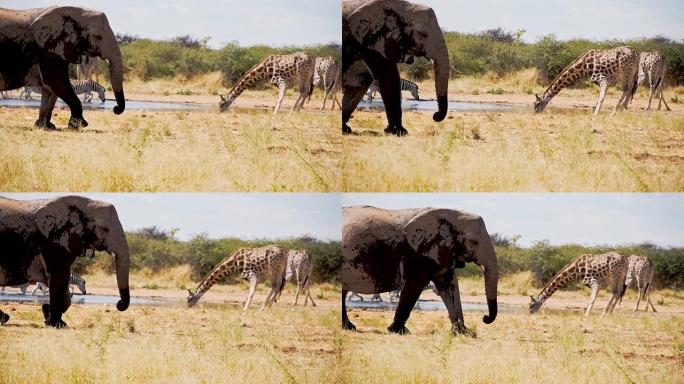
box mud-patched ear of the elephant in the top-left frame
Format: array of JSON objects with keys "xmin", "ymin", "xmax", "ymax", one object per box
[{"xmin": 31, "ymin": 7, "xmax": 87, "ymax": 63}]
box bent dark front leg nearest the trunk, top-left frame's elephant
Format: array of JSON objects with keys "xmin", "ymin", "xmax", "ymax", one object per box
[{"xmin": 40, "ymin": 57, "xmax": 88, "ymax": 129}]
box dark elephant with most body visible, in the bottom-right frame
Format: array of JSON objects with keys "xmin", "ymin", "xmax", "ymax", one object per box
[{"xmin": 341, "ymin": 206, "xmax": 498, "ymax": 334}]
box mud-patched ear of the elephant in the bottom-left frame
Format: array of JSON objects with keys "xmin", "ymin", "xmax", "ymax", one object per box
[{"xmin": 35, "ymin": 199, "xmax": 86, "ymax": 255}]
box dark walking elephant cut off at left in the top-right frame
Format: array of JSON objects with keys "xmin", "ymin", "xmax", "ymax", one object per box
[{"xmin": 342, "ymin": 0, "xmax": 450, "ymax": 136}]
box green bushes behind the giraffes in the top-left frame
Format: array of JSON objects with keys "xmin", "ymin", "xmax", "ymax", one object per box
[{"xmin": 119, "ymin": 36, "xmax": 342, "ymax": 84}]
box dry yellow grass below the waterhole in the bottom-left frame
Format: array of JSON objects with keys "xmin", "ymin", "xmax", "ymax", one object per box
[{"xmin": 0, "ymin": 304, "xmax": 342, "ymax": 384}]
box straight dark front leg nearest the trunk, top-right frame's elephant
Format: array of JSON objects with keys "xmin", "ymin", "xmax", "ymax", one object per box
[{"xmin": 365, "ymin": 54, "xmax": 408, "ymax": 136}]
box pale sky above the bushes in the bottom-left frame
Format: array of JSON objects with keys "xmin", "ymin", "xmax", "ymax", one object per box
[{"xmin": 0, "ymin": 193, "xmax": 342, "ymax": 240}]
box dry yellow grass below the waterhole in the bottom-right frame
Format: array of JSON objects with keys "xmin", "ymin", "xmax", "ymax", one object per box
[{"xmin": 342, "ymin": 311, "xmax": 684, "ymax": 383}]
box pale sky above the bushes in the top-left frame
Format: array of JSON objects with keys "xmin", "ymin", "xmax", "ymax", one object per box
[{"xmin": 9, "ymin": 0, "xmax": 342, "ymax": 48}]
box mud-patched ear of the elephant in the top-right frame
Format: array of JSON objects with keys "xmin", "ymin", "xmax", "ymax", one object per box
[{"xmin": 347, "ymin": 1, "xmax": 406, "ymax": 63}]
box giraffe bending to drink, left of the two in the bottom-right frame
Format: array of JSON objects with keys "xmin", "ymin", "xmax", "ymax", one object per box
[{"xmin": 530, "ymin": 252, "xmax": 627, "ymax": 317}]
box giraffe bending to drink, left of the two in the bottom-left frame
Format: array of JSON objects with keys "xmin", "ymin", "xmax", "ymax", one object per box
[{"xmin": 188, "ymin": 245, "xmax": 287, "ymax": 311}]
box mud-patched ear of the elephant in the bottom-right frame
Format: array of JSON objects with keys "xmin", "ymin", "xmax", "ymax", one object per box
[{"xmin": 404, "ymin": 209, "xmax": 456, "ymax": 266}]
